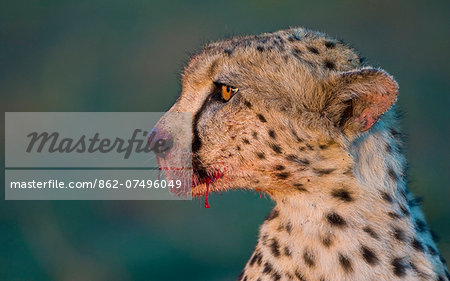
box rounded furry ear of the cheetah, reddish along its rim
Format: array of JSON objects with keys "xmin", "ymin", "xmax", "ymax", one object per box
[{"xmin": 334, "ymin": 68, "xmax": 398, "ymax": 135}]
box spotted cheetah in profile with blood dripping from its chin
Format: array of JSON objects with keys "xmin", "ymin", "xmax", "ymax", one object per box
[{"xmin": 149, "ymin": 28, "xmax": 450, "ymax": 281}]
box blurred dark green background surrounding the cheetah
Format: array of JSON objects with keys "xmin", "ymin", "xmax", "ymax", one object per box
[{"xmin": 0, "ymin": 0, "xmax": 450, "ymax": 280}]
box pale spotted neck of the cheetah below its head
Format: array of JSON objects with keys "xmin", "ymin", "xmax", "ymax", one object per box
[{"xmin": 237, "ymin": 123, "xmax": 444, "ymax": 281}]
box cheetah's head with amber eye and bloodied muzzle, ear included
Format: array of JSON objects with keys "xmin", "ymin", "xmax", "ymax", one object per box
[{"xmin": 150, "ymin": 28, "xmax": 397, "ymax": 199}]
